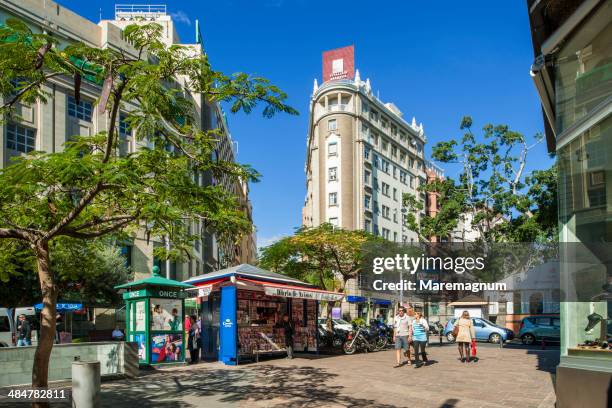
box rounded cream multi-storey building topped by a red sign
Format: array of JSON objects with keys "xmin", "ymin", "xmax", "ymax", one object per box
[{"xmin": 302, "ymin": 46, "xmax": 426, "ymax": 318}]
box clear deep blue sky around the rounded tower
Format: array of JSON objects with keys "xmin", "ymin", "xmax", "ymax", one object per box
[{"xmin": 59, "ymin": 0, "xmax": 552, "ymax": 249}]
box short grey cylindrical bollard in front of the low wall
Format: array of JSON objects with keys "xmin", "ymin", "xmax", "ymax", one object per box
[{"xmin": 72, "ymin": 361, "xmax": 101, "ymax": 408}]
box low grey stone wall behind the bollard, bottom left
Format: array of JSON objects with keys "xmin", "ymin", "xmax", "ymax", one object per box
[{"xmin": 0, "ymin": 342, "xmax": 138, "ymax": 387}]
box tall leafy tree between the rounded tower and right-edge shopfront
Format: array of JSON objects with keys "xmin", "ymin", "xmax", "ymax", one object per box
[{"xmin": 403, "ymin": 116, "xmax": 557, "ymax": 243}]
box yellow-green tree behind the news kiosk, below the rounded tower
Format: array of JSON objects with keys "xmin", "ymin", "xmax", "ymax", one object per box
[{"xmin": 259, "ymin": 223, "xmax": 382, "ymax": 318}]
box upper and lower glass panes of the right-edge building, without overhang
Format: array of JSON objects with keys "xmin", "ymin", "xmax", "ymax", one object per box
[{"xmin": 554, "ymin": 2, "xmax": 612, "ymax": 372}]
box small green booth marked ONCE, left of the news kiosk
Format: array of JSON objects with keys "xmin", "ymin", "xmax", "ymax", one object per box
[{"xmin": 115, "ymin": 266, "xmax": 194, "ymax": 365}]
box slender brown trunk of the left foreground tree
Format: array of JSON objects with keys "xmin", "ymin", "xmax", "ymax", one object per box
[{"xmin": 32, "ymin": 241, "xmax": 58, "ymax": 408}]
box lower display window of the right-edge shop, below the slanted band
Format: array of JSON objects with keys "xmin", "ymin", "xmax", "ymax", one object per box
[{"xmin": 557, "ymin": 100, "xmax": 612, "ymax": 368}]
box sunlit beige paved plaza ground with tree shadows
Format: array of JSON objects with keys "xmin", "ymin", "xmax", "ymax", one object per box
[{"xmin": 0, "ymin": 345, "xmax": 559, "ymax": 408}]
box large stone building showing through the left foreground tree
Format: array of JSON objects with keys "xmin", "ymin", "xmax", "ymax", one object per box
[{"xmin": 0, "ymin": 0, "xmax": 255, "ymax": 286}]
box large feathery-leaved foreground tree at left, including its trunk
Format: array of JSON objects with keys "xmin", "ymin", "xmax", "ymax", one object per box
[{"xmin": 0, "ymin": 19, "xmax": 297, "ymax": 396}]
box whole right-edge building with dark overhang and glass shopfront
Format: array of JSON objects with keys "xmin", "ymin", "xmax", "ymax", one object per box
[{"xmin": 527, "ymin": 0, "xmax": 612, "ymax": 408}]
